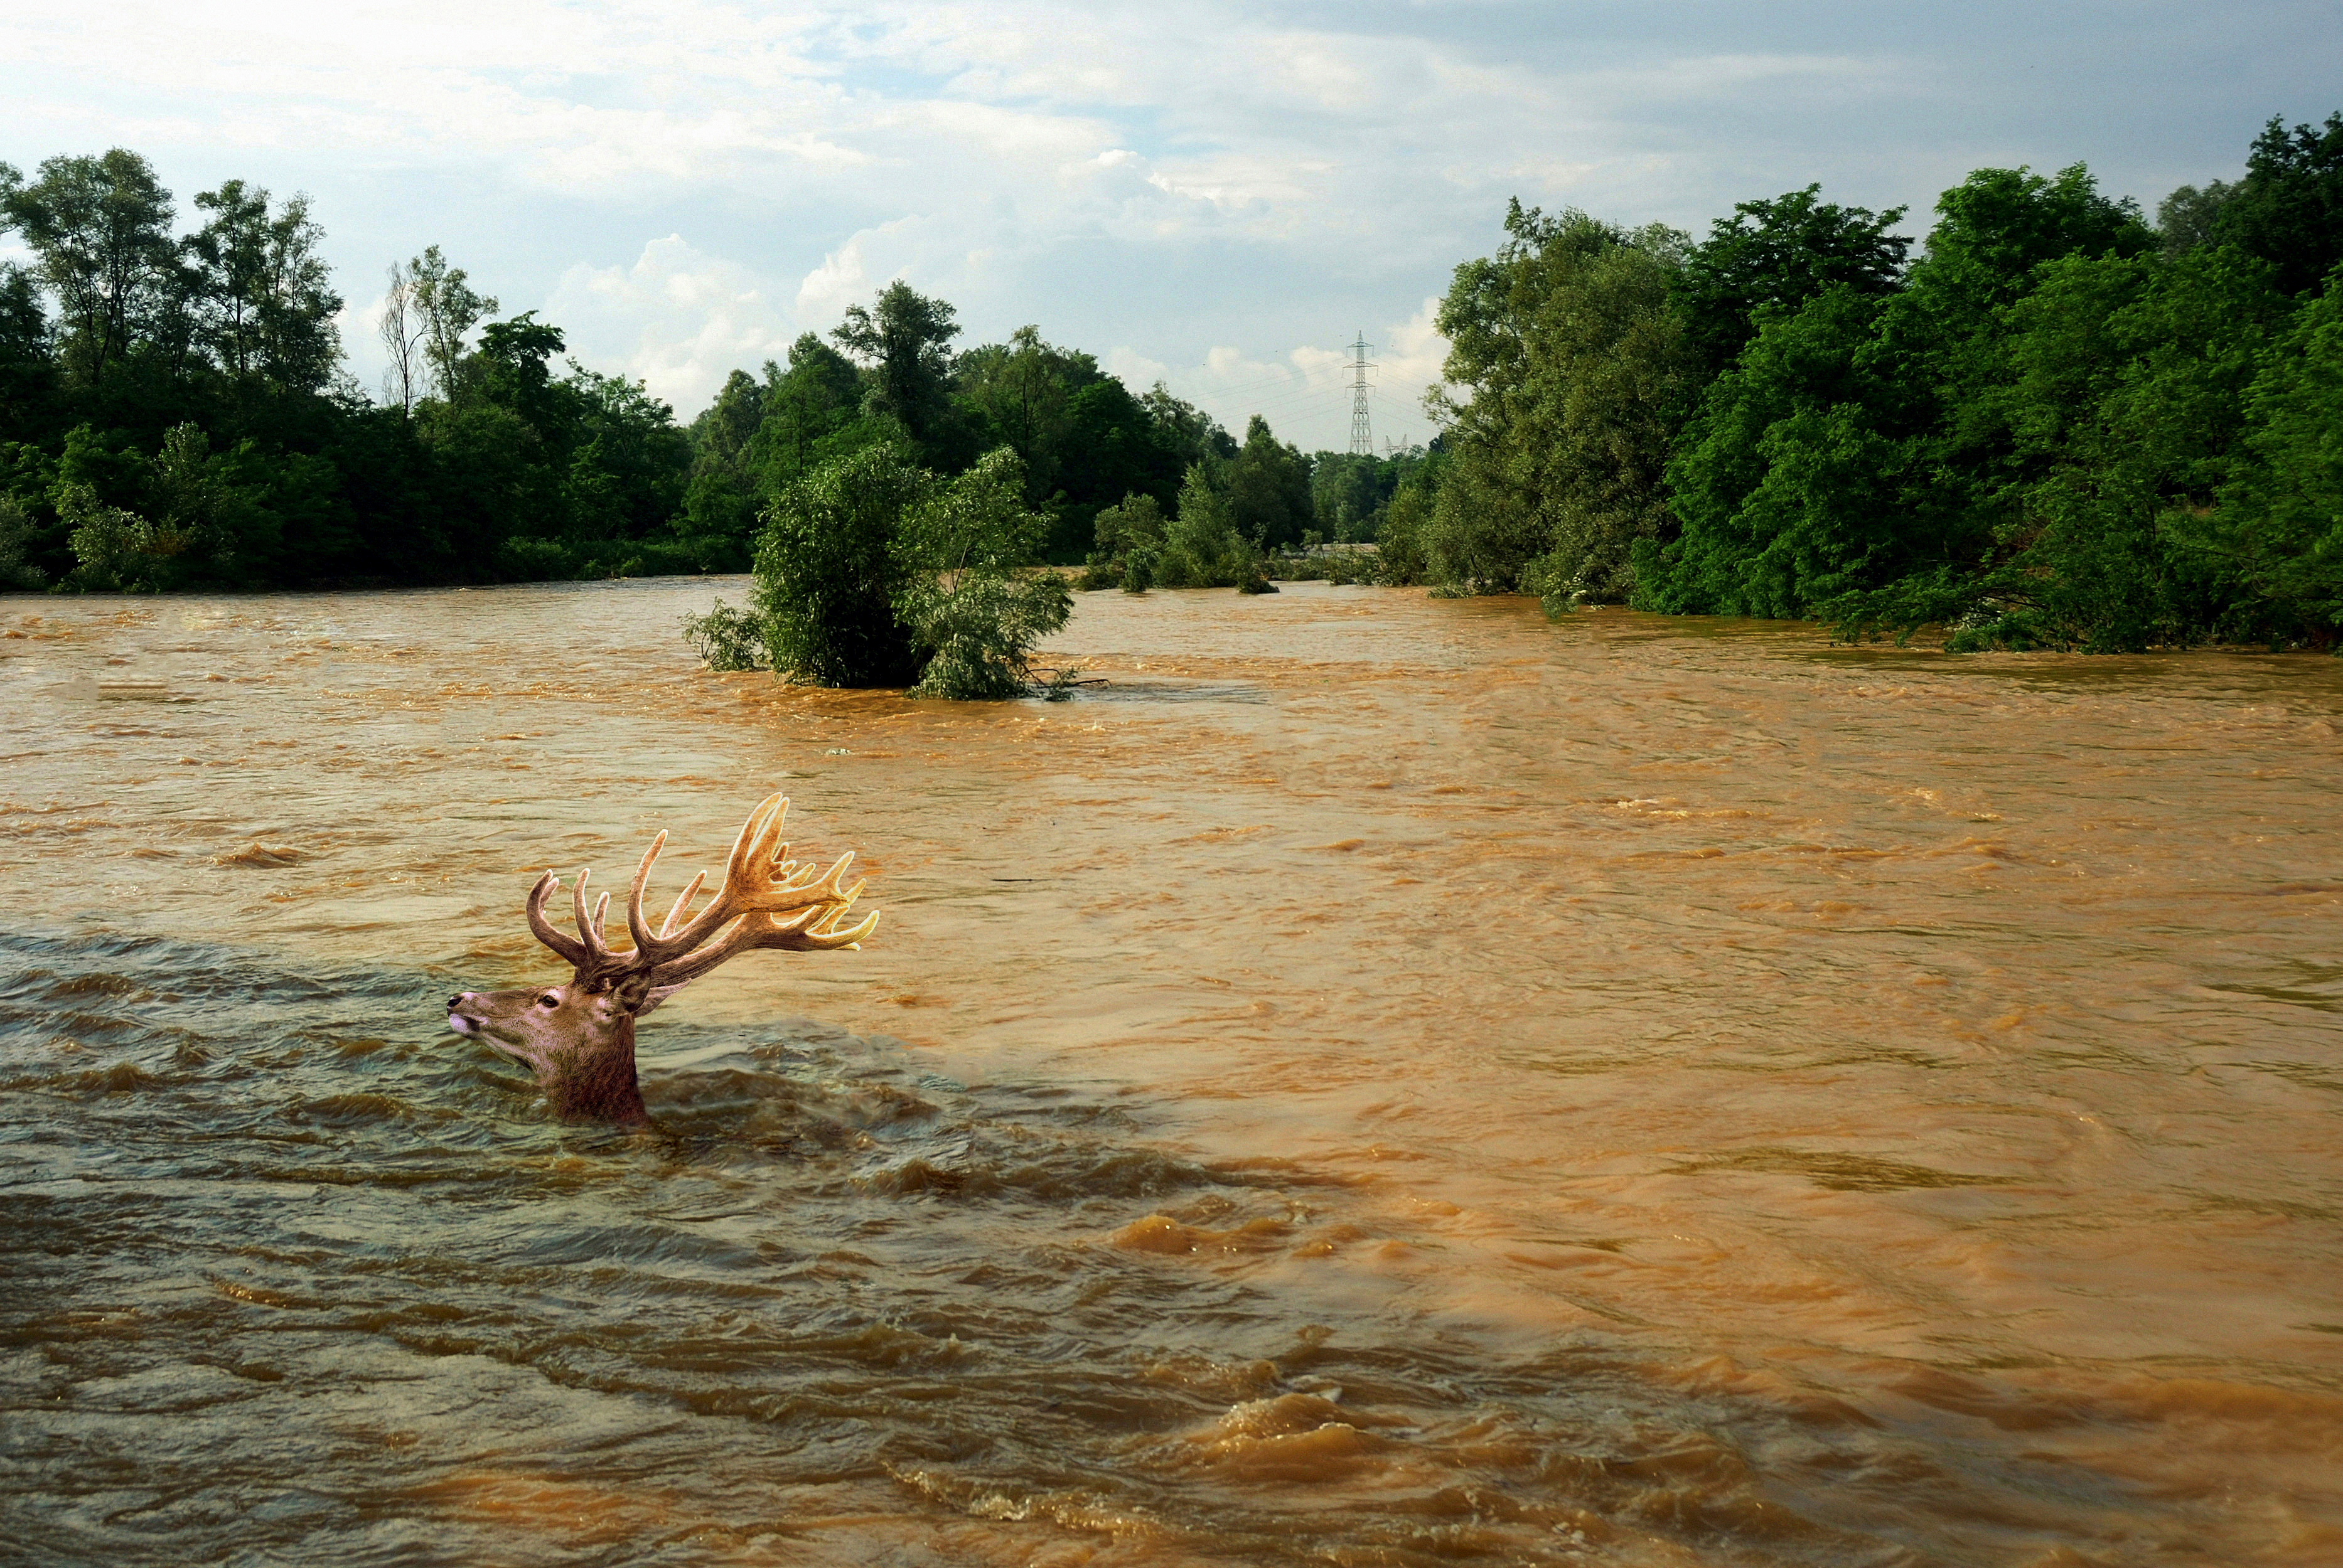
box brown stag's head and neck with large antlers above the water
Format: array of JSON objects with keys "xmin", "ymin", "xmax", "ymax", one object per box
[{"xmin": 448, "ymin": 794, "xmax": 879, "ymax": 1129}]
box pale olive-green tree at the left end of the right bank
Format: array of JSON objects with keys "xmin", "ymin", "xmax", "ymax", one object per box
[{"xmin": 1425, "ymin": 201, "xmax": 1698, "ymax": 607}]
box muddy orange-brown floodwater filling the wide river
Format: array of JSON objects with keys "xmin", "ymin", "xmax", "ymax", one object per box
[{"xmin": 0, "ymin": 581, "xmax": 2343, "ymax": 1568}]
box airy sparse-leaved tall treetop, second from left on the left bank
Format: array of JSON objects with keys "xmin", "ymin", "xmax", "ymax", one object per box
[{"xmin": 188, "ymin": 181, "xmax": 342, "ymax": 394}]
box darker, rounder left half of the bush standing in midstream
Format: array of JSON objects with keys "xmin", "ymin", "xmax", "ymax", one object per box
[{"xmin": 752, "ymin": 443, "xmax": 935, "ymax": 686}]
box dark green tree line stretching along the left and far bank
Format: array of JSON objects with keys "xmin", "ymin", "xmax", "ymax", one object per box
[{"xmin": 0, "ymin": 147, "xmax": 1390, "ymax": 590}]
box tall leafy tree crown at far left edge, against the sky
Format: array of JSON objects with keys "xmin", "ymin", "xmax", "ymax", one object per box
[{"xmin": 0, "ymin": 147, "xmax": 180, "ymax": 385}]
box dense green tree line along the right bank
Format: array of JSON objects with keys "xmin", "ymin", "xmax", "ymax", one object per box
[{"xmin": 1382, "ymin": 115, "xmax": 2343, "ymax": 651}]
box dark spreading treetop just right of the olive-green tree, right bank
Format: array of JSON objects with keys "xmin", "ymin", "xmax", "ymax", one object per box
[{"xmin": 1668, "ymin": 185, "xmax": 1912, "ymax": 375}]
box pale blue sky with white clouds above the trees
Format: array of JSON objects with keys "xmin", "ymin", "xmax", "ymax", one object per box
[{"xmin": 0, "ymin": 0, "xmax": 2343, "ymax": 450}]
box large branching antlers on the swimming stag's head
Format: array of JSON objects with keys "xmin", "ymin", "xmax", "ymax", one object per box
[{"xmin": 527, "ymin": 794, "xmax": 879, "ymax": 991}]
